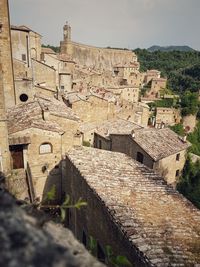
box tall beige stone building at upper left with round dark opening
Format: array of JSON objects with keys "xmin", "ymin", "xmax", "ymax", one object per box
[{"xmin": 11, "ymin": 26, "xmax": 58, "ymax": 104}]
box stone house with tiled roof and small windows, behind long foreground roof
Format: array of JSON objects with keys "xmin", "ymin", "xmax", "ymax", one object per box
[{"xmin": 94, "ymin": 127, "xmax": 189, "ymax": 186}]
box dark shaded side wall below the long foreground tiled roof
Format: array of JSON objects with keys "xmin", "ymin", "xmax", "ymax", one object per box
[{"xmin": 62, "ymin": 158, "xmax": 144, "ymax": 266}]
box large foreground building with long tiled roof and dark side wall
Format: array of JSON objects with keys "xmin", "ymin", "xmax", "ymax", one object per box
[{"xmin": 62, "ymin": 147, "xmax": 200, "ymax": 267}]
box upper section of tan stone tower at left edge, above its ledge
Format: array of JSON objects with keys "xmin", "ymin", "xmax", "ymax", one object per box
[{"xmin": 0, "ymin": 0, "xmax": 16, "ymax": 109}]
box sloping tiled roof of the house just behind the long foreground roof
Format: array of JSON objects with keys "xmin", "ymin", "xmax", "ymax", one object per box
[{"xmin": 134, "ymin": 128, "xmax": 189, "ymax": 161}]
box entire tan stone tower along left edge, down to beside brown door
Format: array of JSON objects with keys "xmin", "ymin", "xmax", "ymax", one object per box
[{"xmin": 0, "ymin": 0, "xmax": 15, "ymax": 174}]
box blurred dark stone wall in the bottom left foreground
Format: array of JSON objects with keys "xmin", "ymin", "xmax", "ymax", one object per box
[{"xmin": 0, "ymin": 183, "xmax": 104, "ymax": 267}]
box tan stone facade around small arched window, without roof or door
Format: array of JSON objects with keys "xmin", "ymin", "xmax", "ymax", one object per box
[{"xmin": 10, "ymin": 128, "xmax": 62, "ymax": 200}]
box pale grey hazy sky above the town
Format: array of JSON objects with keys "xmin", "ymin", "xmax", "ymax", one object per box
[{"xmin": 9, "ymin": 0, "xmax": 200, "ymax": 50}]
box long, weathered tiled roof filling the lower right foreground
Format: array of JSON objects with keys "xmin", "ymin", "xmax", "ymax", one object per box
[{"xmin": 67, "ymin": 148, "xmax": 200, "ymax": 267}]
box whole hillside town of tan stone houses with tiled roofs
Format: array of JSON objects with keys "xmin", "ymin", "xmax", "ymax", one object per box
[{"xmin": 0, "ymin": 0, "xmax": 200, "ymax": 267}]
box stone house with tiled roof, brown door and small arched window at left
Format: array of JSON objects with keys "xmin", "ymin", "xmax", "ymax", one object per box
[{"xmin": 8, "ymin": 98, "xmax": 82, "ymax": 200}]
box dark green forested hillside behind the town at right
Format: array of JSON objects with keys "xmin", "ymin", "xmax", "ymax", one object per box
[{"xmin": 134, "ymin": 48, "xmax": 200, "ymax": 94}]
